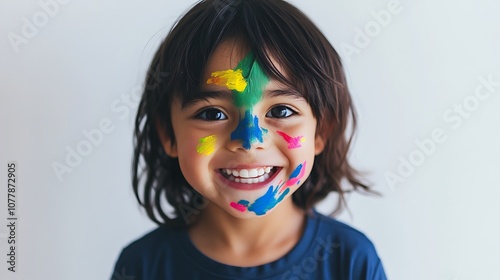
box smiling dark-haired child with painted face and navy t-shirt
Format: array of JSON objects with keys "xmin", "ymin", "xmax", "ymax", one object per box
[{"xmin": 112, "ymin": 0, "xmax": 386, "ymax": 280}]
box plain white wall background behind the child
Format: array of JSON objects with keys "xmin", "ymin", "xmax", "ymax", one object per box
[{"xmin": 0, "ymin": 0, "xmax": 500, "ymax": 280}]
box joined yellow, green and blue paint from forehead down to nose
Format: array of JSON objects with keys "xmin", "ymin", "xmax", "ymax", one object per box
[{"xmin": 207, "ymin": 52, "xmax": 269, "ymax": 150}]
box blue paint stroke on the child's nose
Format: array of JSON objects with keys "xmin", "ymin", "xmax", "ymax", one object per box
[{"xmin": 231, "ymin": 110, "xmax": 267, "ymax": 150}]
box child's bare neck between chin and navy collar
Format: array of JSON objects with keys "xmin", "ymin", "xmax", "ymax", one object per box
[{"xmin": 189, "ymin": 197, "xmax": 305, "ymax": 266}]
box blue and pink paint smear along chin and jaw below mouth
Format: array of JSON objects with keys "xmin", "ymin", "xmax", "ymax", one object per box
[{"xmin": 230, "ymin": 162, "xmax": 306, "ymax": 216}]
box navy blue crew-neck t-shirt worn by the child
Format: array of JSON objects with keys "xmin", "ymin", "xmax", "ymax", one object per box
[{"xmin": 111, "ymin": 212, "xmax": 387, "ymax": 280}]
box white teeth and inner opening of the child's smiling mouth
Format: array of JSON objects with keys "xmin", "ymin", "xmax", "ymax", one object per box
[{"xmin": 219, "ymin": 166, "xmax": 279, "ymax": 184}]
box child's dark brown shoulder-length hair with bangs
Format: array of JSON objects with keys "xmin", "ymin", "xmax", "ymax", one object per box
[{"xmin": 132, "ymin": 0, "xmax": 376, "ymax": 228}]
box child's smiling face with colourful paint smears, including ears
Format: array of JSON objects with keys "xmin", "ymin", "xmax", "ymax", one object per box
[{"xmin": 163, "ymin": 42, "xmax": 324, "ymax": 218}]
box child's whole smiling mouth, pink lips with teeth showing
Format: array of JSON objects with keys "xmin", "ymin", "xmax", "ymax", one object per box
[{"xmin": 219, "ymin": 166, "xmax": 281, "ymax": 190}]
